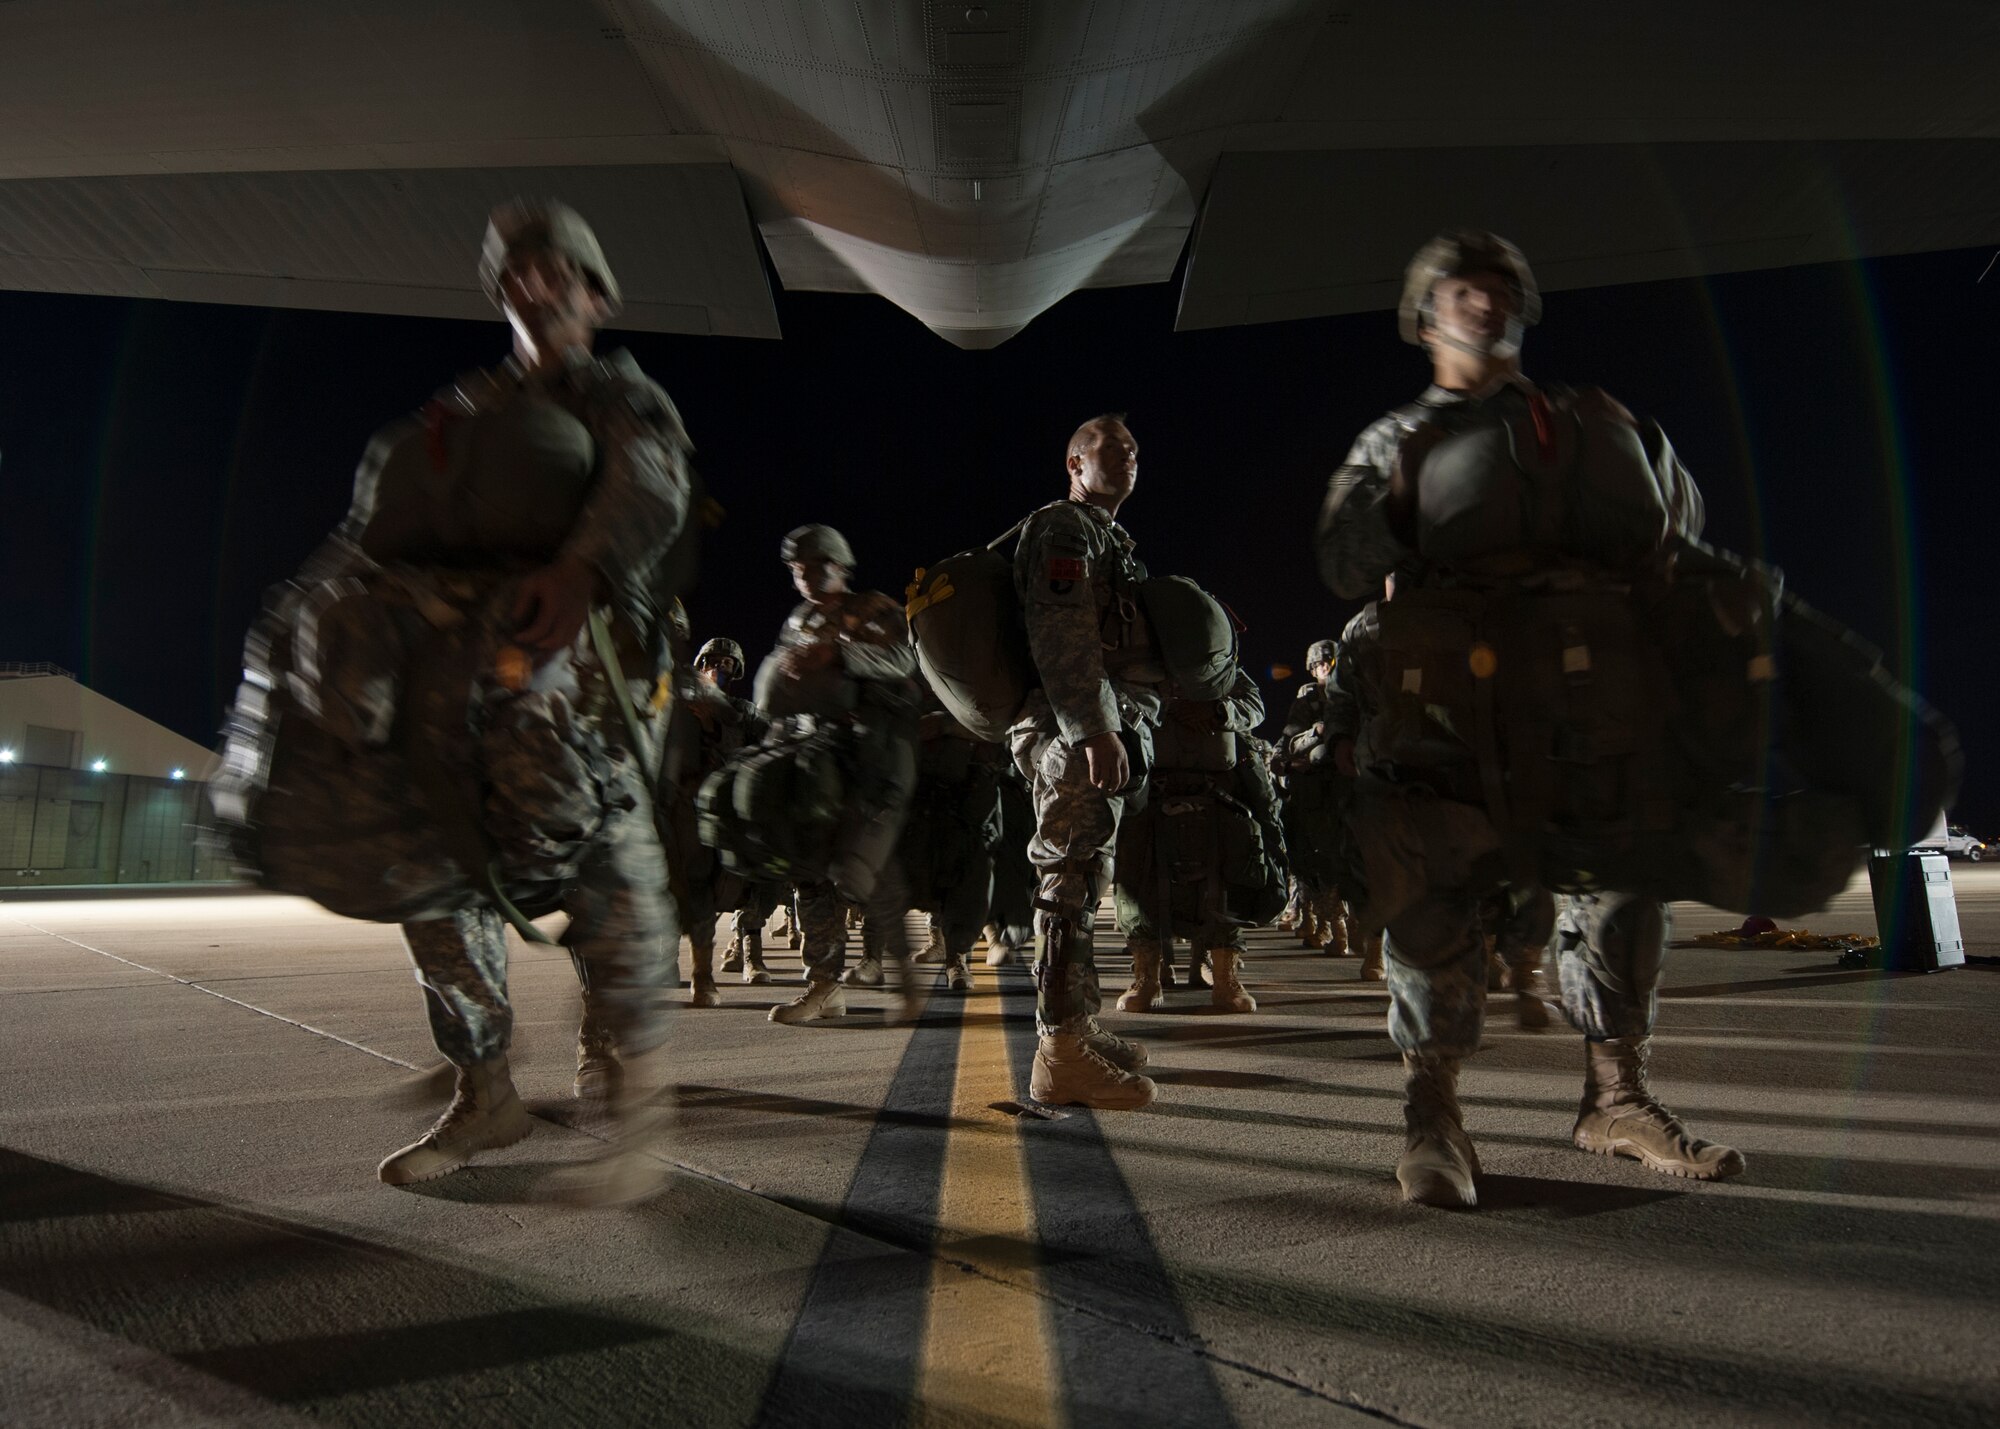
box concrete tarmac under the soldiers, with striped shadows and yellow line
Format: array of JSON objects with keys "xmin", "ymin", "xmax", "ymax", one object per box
[{"xmin": 0, "ymin": 865, "xmax": 2000, "ymax": 1429}]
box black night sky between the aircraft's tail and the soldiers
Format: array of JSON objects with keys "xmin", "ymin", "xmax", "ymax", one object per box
[{"xmin": 0, "ymin": 245, "xmax": 2000, "ymax": 835}]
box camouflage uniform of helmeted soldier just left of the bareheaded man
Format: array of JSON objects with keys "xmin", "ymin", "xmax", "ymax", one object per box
[{"xmin": 758, "ymin": 590, "xmax": 918, "ymax": 981}]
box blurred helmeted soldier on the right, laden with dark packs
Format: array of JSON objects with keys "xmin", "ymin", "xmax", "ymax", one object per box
[{"xmin": 1318, "ymin": 230, "xmax": 1956, "ymax": 1205}]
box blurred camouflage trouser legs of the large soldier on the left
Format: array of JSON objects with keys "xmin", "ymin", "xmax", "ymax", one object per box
[{"xmin": 402, "ymin": 759, "xmax": 680, "ymax": 1067}]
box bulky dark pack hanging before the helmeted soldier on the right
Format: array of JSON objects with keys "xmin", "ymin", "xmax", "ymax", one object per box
[{"xmin": 1356, "ymin": 544, "xmax": 1958, "ymax": 917}]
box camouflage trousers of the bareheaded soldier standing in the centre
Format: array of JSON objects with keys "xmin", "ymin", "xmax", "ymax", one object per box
[{"xmin": 1008, "ymin": 696, "xmax": 1126, "ymax": 1037}]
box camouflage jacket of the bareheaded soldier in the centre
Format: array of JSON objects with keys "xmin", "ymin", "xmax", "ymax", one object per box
[{"xmin": 1014, "ymin": 500, "xmax": 1164, "ymax": 743}]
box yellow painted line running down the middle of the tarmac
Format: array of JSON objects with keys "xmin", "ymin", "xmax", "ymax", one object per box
[{"xmin": 916, "ymin": 969, "xmax": 1064, "ymax": 1429}]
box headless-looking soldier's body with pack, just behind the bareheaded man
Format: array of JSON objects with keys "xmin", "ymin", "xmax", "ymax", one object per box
[{"xmin": 1112, "ymin": 670, "xmax": 1284, "ymax": 1013}]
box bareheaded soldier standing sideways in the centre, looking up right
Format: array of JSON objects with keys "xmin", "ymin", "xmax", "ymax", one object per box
[{"xmin": 1008, "ymin": 416, "xmax": 1166, "ymax": 1109}]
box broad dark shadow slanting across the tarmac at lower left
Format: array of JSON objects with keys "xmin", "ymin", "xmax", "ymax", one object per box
[{"xmin": 0, "ymin": 1149, "xmax": 766, "ymax": 1425}]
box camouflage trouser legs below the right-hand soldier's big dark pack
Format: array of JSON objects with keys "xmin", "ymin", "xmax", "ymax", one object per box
[{"xmin": 1382, "ymin": 893, "xmax": 1672, "ymax": 1059}]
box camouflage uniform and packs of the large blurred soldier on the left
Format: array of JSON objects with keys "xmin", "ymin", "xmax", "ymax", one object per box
[{"xmin": 218, "ymin": 352, "xmax": 696, "ymax": 1067}]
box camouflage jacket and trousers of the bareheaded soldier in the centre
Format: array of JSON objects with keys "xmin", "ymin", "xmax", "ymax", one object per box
[{"xmin": 1008, "ymin": 500, "xmax": 1166, "ymax": 1037}]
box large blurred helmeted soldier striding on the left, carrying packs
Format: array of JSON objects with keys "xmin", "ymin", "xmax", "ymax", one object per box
[{"xmin": 218, "ymin": 200, "xmax": 700, "ymax": 1199}]
